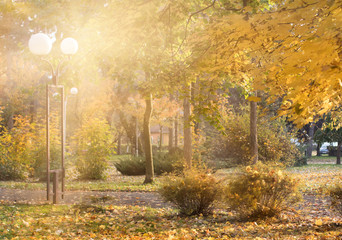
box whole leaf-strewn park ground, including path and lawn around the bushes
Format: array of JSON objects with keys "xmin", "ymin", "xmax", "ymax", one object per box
[{"xmin": 0, "ymin": 156, "xmax": 342, "ymax": 239}]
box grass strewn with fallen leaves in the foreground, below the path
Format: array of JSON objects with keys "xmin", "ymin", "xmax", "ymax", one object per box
[{"xmin": 0, "ymin": 204, "xmax": 342, "ymax": 239}]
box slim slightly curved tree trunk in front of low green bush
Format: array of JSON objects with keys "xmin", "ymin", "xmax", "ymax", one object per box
[{"xmin": 144, "ymin": 94, "xmax": 154, "ymax": 184}]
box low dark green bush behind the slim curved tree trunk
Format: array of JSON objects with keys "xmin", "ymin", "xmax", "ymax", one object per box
[{"xmin": 114, "ymin": 148, "xmax": 183, "ymax": 176}]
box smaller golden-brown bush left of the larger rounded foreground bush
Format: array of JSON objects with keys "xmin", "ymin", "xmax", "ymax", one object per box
[{"xmin": 159, "ymin": 170, "xmax": 221, "ymax": 216}]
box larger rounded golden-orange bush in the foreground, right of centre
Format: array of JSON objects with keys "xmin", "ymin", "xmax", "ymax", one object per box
[{"xmin": 224, "ymin": 163, "xmax": 299, "ymax": 219}]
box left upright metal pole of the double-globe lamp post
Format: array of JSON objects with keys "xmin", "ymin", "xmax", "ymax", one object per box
[{"xmin": 46, "ymin": 84, "xmax": 50, "ymax": 201}]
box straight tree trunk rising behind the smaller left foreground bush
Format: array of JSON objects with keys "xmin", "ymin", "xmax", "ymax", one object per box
[{"xmin": 183, "ymin": 86, "xmax": 192, "ymax": 168}]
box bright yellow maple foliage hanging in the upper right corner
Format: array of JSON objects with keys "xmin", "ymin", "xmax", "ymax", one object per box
[{"xmin": 194, "ymin": 1, "xmax": 342, "ymax": 125}]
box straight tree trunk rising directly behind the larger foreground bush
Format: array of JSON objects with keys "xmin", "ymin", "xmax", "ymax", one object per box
[{"xmin": 250, "ymin": 101, "xmax": 259, "ymax": 164}]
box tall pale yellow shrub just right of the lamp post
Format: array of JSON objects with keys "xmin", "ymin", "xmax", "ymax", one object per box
[{"xmin": 74, "ymin": 118, "xmax": 114, "ymax": 180}]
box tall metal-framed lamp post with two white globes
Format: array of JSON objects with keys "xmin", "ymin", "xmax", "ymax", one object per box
[{"xmin": 29, "ymin": 33, "xmax": 78, "ymax": 203}]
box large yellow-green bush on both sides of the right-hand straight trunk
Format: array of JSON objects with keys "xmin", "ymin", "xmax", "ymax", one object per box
[{"xmin": 210, "ymin": 111, "xmax": 301, "ymax": 166}]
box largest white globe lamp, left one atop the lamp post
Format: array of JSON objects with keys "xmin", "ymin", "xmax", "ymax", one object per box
[{"xmin": 29, "ymin": 33, "xmax": 52, "ymax": 55}]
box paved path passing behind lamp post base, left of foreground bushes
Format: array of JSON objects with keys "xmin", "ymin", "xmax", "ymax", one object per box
[{"xmin": 0, "ymin": 188, "xmax": 171, "ymax": 208}]
